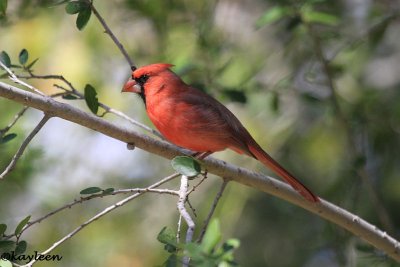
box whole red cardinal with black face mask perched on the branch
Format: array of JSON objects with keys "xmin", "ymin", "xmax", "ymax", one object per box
[{"xmin": 122, "ymin": 63, "xmax": 319, "ymax": 202}]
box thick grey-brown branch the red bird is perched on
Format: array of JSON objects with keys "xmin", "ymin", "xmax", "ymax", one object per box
[{"xmin": 0, "ymin": 82, "xmax": 400, "ymax": 262}]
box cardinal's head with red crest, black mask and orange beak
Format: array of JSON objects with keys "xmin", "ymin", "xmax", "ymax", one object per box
[{"xmin": 122, "ymin": 63, "xmax": 174, "ymax": 98}]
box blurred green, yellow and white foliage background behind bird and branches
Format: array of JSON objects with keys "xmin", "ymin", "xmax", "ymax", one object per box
[{"xmin": 0, "ymin": 0, "xmax": 400, "ymax": 267}]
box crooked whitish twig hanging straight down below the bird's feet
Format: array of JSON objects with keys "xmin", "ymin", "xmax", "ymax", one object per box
[{"xmin": 177, "ymin": 175, "xmax": 195, "ymax": 267}]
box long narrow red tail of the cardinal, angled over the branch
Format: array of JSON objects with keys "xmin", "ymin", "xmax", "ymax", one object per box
[{"xmin": 248, "ymin": 144, "xmax": 319, "ymax": 202}]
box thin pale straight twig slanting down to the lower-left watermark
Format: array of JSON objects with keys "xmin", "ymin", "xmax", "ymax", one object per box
[{"xmin": 17, "ymin": 174, "xmax": 178, "ymax": 267}]
